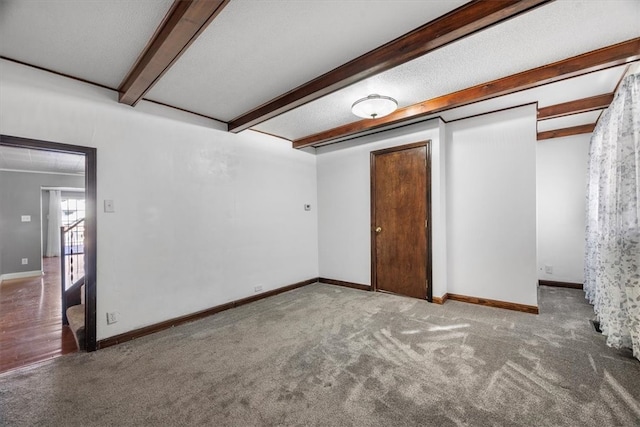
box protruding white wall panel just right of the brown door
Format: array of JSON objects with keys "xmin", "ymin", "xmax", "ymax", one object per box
[{"xmin": 446, "ymin": 105, "xmax": 537, "ymax": 305}]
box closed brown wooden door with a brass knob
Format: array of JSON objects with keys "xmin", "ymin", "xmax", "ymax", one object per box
[{"xmin": 371, "ymin": 141, "xmax": 431, "ymax": 300}]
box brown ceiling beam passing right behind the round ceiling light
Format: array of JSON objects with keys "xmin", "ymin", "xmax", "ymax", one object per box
[{"xmin": 293, "ymin": 38, "xmax": 640, "ymax": 148}]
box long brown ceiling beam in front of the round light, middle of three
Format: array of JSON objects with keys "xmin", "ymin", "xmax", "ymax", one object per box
[{"xmin": 229, "ymin": 0, "xmax": 553, "ymax": 133}]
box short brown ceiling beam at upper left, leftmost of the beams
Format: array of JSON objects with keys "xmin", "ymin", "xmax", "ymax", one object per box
[{"xmin": 118, "ymin": 0, "xmax": 230, "ymax": 105}]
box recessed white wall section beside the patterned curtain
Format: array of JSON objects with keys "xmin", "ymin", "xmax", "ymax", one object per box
[{"xmin": 536, "ymin": 134, "xmax": 591, "ymax": 283}]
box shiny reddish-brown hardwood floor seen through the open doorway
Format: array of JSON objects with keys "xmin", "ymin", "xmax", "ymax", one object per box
[{"xmin": 0, "ymin": 258, "xmax": 77, "ymax": 373}]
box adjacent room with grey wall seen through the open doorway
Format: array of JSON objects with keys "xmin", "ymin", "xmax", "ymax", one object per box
[{"xmin": 0, "ymin": 145, "xmax": 85, "ymax": 371}]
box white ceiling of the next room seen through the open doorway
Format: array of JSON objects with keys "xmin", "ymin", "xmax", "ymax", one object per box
[{"xmin": 0, "ymin": 145, "xmax": 85, "ymax": 175}]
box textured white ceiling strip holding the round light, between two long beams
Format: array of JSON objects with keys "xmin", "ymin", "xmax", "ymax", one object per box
[{"xmin": 255, "ymin": 0, "xmax": 640, "ymax": 139}]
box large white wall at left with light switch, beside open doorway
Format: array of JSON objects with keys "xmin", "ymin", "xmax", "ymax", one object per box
[{"xmin": 0, "ymin": 61, "xmax": 318, "ymax": 339}]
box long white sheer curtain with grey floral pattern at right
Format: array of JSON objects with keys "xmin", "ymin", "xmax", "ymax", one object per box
[{"xmin": 584, "ymin": 74, "xmax": 640, "ymax": 359}]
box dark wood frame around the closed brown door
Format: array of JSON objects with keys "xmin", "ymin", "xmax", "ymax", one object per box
[{"xmin": 369, "ymin": 139, "xmax": 433, "ymax": 302}]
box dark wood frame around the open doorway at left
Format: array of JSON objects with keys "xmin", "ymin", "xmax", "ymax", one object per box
[{"xmin": 0, "ymin": 134, "xmax": 98, "ymax": 351}]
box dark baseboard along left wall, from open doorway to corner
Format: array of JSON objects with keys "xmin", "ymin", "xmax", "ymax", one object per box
[{"xmin": 98, "ymin": 277, "xmax": 318, "ymax": 349}]
